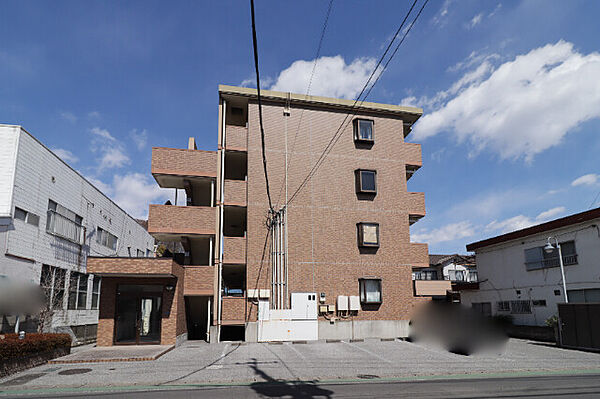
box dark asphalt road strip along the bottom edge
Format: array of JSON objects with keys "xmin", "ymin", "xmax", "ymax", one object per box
[{"xmin": 8, "ymin": 374, "xmax": 600, "ymax": 399}]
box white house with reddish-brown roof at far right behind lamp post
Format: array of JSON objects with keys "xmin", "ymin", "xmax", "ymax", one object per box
[{"xmin": 461, "ymin": 208, "xmax": 600, "ymax": 326}]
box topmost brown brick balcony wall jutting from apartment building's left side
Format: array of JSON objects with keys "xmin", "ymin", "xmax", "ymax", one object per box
[{"xmin": 152, "ymin": 147, "xmax": 217, "ymax": 177}]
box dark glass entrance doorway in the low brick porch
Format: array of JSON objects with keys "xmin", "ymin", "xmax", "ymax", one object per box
[{"xmin": 114, "ymin": 285, "xmax": 163, "ymax": 345}]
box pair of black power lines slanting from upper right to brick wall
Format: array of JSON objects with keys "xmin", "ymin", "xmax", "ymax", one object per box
[{"xmin": 288, "ymin": 0, "xmax": 429, "ymax": 204}]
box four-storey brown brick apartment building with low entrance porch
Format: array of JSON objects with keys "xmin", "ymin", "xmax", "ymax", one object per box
[{"xmin": 89, "ymin": 86, "xmax": 429, "ymax": 345}]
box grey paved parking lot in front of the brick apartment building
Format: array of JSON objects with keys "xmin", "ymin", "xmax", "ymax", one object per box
[{"xmin": 0, "ymin": 339, "xmax": 600, "ymax": 394}]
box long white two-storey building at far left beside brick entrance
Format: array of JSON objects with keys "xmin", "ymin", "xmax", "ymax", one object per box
[{"xmin": 0, "ymin": 125, "xmax": 154, "ymax": 340}]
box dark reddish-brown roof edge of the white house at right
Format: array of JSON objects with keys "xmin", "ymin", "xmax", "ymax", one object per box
[{"xmin": 467, "ymin": 208, "xmax": 600, "ymax": 251}]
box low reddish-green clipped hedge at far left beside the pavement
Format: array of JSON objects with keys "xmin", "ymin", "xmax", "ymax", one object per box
[{"xmin": 0, "ymin": 333, "xmax": 71, "ymax": 361}]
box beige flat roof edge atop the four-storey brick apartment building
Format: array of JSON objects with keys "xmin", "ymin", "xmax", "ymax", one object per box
[{"xmin": 219, "ymin": 85, "xmax": 423, "ymax": 123}]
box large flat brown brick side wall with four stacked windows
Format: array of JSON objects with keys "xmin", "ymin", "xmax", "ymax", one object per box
[{"xmin": 241, "ymin": 102, "xmax": 428, "ymax": 320}]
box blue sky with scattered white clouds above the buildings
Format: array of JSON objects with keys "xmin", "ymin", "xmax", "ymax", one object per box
[{"xmin": 0, "ymin": 0, "xmax": 600, "ymax": 253}]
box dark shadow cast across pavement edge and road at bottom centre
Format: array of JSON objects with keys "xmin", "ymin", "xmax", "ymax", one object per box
[{"xmin": 250, "ymin": 358, "xmax": 334, "ymax": 398}]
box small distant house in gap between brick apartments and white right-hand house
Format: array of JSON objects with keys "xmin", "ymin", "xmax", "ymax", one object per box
[{"xmin": 412, "ymin": 254, "xmax": 477, "ymax": 301}]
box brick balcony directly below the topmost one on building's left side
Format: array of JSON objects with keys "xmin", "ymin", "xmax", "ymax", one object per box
[{"xmin": 148, "ymin": 205, "xmax": 217, "ymax": 241}]
